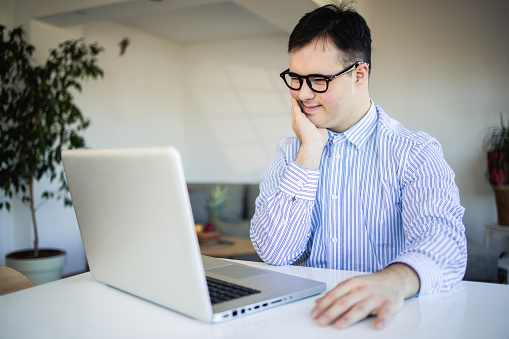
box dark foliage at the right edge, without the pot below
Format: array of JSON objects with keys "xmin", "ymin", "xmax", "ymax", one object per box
[{"xmin": 484, "ymin": 113, "xmax": 509, "ymax": 186}]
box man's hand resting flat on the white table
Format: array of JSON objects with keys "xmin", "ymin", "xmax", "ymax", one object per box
[{"xmin": 311, "ymin": 263, "xmax": 420, "ymax": 330}]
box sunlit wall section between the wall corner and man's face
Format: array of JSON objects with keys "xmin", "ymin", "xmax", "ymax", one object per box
[{"xmin": 184, "ymin": 36, "xmax": 293, "ymax": 183}]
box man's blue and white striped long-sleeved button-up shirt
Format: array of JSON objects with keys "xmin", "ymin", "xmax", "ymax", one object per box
[{"xmin": 251, "ymin": 103, "xmax": 467, "ymax": 295}]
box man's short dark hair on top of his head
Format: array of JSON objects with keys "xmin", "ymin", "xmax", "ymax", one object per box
[{"xmin": 288, "ymin": 2, "xmax": 371, "ymax": 68}]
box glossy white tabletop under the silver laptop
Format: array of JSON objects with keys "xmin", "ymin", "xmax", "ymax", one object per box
[{"xmin": 0, "ymin": 262, "xmax": 509, "ymax": 339}]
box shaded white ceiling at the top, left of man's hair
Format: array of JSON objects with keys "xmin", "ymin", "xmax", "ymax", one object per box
[{"xmin": 36, "ymin": 0, "xmax": 319, "ymax": 45}]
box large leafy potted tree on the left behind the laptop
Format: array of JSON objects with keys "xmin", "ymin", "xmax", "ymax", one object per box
[{"xmin": 0, "ymin": 25, "xmax": 103, "ymax": 284}]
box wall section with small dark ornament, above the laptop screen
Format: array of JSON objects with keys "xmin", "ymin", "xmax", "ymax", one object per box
[{"xmin": 82, "ymin": 23, "xmax": 185, "ymax": 148}]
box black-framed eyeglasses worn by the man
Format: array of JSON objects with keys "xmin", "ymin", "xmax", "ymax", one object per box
[{"xmin": 279, "ymin": 61, "xmax": 369, "ymax": 93}]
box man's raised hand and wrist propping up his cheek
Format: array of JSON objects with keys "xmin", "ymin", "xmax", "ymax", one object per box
[{"xmin": 292, "ymin": 97, "xmax": 329, "ymax": 169}]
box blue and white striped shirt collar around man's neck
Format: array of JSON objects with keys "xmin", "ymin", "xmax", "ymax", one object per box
[{"xmin": 328, "ymin": 100, "xmax": 377, "ymax": 148}]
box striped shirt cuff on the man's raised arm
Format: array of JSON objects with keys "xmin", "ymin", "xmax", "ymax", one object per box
[{"xmin": 279, "ymin": 161, "xmax": 320, "ymax": 201}]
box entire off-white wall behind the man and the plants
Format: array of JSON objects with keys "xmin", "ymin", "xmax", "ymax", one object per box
[{"xmin": 0, "ymin": 0, "xmax": 509, "ymax": 273}]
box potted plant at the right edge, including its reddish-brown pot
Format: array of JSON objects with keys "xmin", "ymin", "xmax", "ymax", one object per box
[{"xmin": 484, "ymin": 113, "xmax": 509, "ymax": 226}]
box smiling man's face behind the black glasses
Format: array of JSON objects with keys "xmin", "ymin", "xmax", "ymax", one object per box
[{"xmin": 290, "ymin": 41, "xmax": 358, "ymax": 133}]
